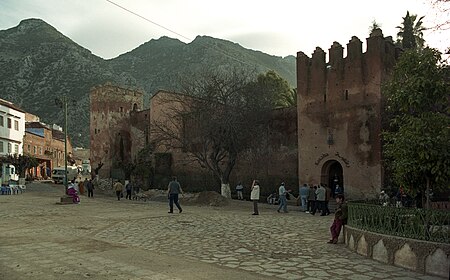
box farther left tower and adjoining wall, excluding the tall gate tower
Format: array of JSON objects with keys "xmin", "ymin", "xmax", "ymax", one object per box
[{"xmin": 90, "ymin": 87, "xmax": 298, "ymax": 194}]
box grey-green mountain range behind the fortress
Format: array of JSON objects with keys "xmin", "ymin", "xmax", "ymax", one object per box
[{"xmin": 0, "ymin": 19, "xmax": 296, "ymax": 147}]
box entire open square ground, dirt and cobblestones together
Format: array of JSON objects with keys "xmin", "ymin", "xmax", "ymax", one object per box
[{"xmin": 0, "ymin": 184, "xmax": 440, "ymax": 280}]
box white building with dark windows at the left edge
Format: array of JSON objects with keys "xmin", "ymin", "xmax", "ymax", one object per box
[{"xmin": 0, "ymin": 99, "xmax": 25, "ymax": 157}]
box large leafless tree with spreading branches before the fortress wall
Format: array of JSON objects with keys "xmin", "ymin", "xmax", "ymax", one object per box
[{"xmin": 151, "ymin": 70, "xmax": 276, "ymax": 197}]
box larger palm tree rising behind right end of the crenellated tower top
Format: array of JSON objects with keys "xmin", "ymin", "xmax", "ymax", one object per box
[{"xmin": 397, "ymin": 11, "xmax": 427, "ymax": 50}]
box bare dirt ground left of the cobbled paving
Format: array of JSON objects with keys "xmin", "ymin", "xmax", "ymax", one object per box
[{"xmin": 0, "ymin": 184, "xmax": 270, "ymax": 280}]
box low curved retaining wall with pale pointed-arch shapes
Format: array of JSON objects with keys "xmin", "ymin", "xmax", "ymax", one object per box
[{"xmin": 344, "ymin": 226, "xmax": 450, "ymax": 279}]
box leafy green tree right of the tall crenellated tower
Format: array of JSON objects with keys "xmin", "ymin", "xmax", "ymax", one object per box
[{"xmin": 383, "ymin": 48, "xmax": 450, "ymax": 190}]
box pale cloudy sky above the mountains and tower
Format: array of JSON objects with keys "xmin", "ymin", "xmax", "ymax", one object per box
[{"xmin": 0, "ymin": 0, "xmax": 450, "ymax": 59}]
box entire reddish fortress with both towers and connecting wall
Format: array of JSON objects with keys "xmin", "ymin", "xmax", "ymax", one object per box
[{"xmin": 90, "ymin": 29, "xmax": 399, "ymax": 199}]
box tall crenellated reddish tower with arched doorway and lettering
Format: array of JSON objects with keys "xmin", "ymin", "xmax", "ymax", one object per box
[{"xmin": 297, "ymin": 29, "xmax": 399, "ymax": 199}]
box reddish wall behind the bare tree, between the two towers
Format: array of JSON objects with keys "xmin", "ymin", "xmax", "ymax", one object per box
[{"xmin": 150, "ymin": 91, "xmax": 298, "ymax": 195}]
